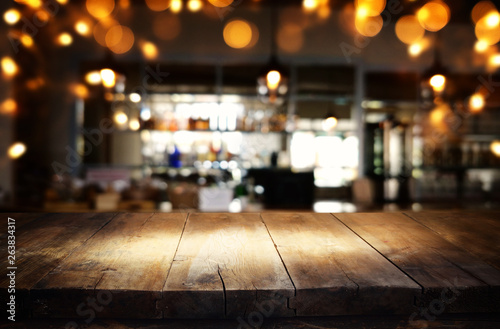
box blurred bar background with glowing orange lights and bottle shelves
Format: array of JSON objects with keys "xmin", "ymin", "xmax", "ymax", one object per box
[{"xmin": 0, "ymin": 0, "xmax": 500, "ymax": 212}]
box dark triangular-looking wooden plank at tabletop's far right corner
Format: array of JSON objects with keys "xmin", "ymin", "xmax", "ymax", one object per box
[{"xmin": 406, "ymin": 211, "xmax": 500, "ymax": 269}]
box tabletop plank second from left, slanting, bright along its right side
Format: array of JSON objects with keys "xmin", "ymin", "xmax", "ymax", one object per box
[{"xmin": 31, "ymin": 213, "xmax": 187, "ymax": 319}]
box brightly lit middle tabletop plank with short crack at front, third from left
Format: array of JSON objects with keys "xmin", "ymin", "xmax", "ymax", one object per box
[{"xmin": 162, "ymin": 213, "xmax": 294, "ymax": 318}]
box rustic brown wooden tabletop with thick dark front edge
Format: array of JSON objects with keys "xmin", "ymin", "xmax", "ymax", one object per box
[{"xmin": 0, "ymin": 212, "xmax": 500, "ymax": 328}]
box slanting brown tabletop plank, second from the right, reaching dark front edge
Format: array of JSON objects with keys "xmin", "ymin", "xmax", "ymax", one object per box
[{"xmin": 335, "ymin": 213, "xmax": 500, "ymax": 316}]
